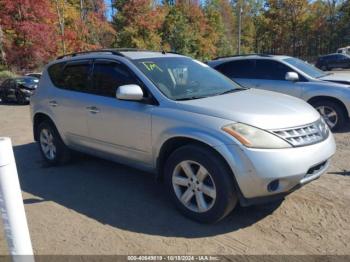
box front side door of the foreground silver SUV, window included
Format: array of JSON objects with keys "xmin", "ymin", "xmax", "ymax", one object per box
[{"xmin": 88, "ymin": 59, "xmax": 153, "ymax": 166}]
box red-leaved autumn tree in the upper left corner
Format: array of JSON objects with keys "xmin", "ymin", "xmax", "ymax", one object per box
[{"xmin": 0, "ymin": 0, "xmax": 57, "ymax": 69}]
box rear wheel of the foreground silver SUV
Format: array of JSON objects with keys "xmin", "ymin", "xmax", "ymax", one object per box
[{"xmin": 37, "ymin": 121, "xmax": 71, "ymax": 166}]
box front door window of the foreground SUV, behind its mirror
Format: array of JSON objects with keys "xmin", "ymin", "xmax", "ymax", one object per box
[{"xmin": 92, "ymin": 61, "xmax": 140, "ymax": 97}]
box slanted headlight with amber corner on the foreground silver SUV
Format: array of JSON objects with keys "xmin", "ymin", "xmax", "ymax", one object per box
[{"xmin": 222, "ymin": 123, "xmax": 292, "ymax": 149}]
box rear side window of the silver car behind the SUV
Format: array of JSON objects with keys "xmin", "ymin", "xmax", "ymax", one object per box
[{"xmin": 216, "ymin": 59, "xmax": 255, "ymax": 78}]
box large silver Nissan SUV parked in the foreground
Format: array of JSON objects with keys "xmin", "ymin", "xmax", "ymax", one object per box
[{"xmin": 31, "ymin": 49, "xmax": 335, "ymax": 222}]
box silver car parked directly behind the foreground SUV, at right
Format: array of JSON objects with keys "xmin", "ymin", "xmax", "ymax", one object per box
[{"xmin": 208, "ymin": 55, "xmax": 350, "ymax": 130}]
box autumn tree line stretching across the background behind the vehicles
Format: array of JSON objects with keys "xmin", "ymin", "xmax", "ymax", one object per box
[{"xmin": 0, "ymin": 0, "xmax": 350, "ymax": 71}]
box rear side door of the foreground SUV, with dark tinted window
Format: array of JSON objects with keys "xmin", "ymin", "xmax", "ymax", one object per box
[{"xmin": 47, "ymin": 60, "xmax": 92, "ymax": 146}]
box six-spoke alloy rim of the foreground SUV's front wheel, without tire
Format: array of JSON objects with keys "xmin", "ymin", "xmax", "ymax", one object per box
[{"xmin": 172, "ymin": 160, "xmax": 216, "ymax": 213}]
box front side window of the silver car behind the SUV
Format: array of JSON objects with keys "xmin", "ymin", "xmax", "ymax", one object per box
[{"xmin": 255, "ymin": 59, "xmax": 293, "ymax": 80}]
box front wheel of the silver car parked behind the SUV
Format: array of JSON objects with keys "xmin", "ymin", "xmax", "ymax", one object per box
[{"xmin": 312, "ymin": 100, "xmax": 347, "ymax": 131}]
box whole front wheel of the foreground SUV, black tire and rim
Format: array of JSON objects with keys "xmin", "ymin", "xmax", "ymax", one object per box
[{"xmin": 164, "ymin": 145, "xmax": 238, "ymax": 223}]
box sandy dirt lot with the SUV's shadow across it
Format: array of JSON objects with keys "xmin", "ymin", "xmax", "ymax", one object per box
[{"xmin": 0, "ymin": 105, "xmax": 350, "ymax": 255}]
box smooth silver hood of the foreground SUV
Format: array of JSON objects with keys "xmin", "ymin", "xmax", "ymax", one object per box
[{"xmin": 178, "ymin": 89, "xmax": 320, "ymax": 130}]
